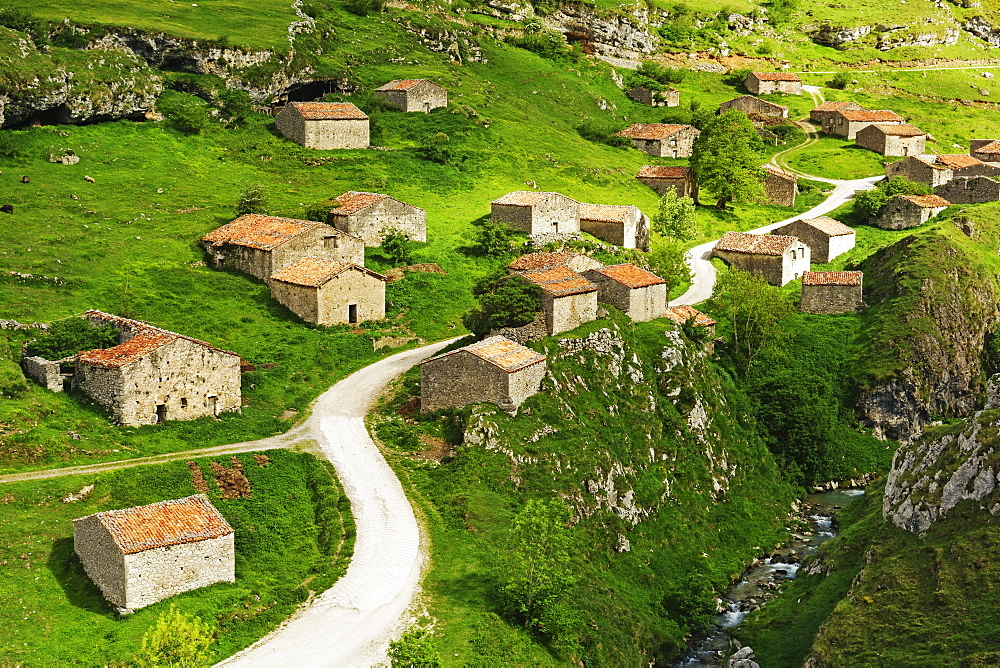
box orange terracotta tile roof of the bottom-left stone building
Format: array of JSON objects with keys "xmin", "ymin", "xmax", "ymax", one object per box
[{"xmin": 73, "ymin": 494, "xmax": 233, "ymax": 554}]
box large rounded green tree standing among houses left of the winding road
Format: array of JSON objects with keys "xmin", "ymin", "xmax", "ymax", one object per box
[{"xmin": 691, "ymin": 109, "xmax": 764, "ymax": 209}]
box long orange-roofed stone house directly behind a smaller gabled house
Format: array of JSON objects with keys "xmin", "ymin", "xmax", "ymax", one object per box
[{"xmin": 201, "ymin": 213, "xmax": 365, "ymax": 281}]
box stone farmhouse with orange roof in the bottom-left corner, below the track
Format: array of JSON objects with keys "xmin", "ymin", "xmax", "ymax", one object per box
[{"xmin": 73, "ymin": 494, "xmax": 236, "ymax": 612}]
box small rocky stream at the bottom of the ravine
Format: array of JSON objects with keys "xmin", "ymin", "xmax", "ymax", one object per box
[{"xmin": 674, "ymin": 489, "xmax": 865, "ymax": 668}]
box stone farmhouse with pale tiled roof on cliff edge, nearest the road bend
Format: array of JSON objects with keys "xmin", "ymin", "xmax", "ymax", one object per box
[{"xmin": 420, "ymin": 336, "xmax": 545, "ymax": 412}]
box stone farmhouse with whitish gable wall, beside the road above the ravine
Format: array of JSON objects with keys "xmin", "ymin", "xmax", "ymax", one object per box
[{"xmin": 712, "ymin": 232, "xmax": 809, "ymax": 285}]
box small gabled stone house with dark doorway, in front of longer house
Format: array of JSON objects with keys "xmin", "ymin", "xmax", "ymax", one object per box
[{"xmin": 270, "ymin": 257, "xmax": 388, "ymax": 325}]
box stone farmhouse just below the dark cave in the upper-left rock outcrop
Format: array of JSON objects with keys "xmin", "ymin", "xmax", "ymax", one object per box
[{"xmin": 274, "ymin": 102, "xmax": 369, "ymax": 150}]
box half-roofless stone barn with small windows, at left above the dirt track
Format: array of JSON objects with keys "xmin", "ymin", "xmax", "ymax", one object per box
[{"xmin": 73, "ymin": 311, "xmax": 242, "ymax": 427}]
